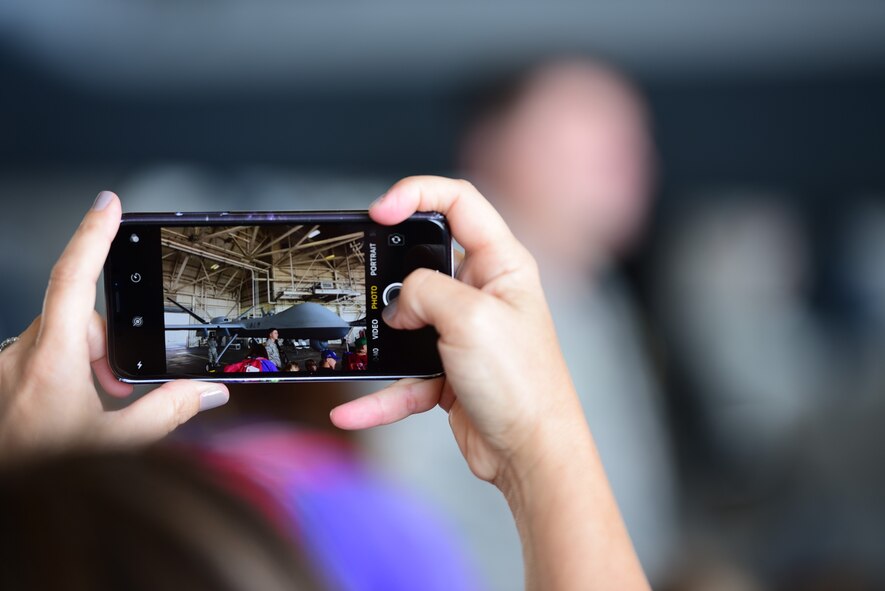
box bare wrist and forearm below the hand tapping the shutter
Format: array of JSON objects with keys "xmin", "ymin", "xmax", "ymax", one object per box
[{"xmin": 495, "ymin": 390, "xmax": 648, "ymax": 590}]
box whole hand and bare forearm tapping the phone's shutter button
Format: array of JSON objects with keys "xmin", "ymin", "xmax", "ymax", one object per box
[{"xmin": 331, "ymin": 177, "xmax": 648, "ymax": 591}]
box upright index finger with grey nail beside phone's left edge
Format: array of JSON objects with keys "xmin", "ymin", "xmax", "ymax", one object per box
[{"xmin": 37, "ymin": 191, "xmax": 121, "ymax": 345}]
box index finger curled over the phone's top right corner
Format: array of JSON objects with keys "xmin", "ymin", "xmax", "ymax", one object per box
[{"xmin": 369, "ymin": 176, "xmax": 518, "ymax": 254}]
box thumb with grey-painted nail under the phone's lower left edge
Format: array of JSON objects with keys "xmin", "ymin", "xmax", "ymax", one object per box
[{"xmin": 99, "ymin": 380, "xmax": 230, "ymax": 444}]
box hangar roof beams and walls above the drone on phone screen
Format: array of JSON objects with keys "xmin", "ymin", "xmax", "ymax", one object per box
[{"xmin": 161, "ymin": 224, "xmax": 366, "ymax": 347}]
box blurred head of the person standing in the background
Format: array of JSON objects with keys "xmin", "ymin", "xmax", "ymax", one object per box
[{"xmin": 461, "ymin": 58, "xmax": 653, "ymax": 266}]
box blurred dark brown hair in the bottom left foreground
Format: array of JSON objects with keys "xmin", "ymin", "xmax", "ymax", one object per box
[{"xmin": 0, "ymin": 449, "xmax": 320, "ymax": 591}]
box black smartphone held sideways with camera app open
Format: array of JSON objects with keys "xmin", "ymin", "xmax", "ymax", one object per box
[{"xmin": 104, "ymin": 211, "xmax": 453, "ymax": 383}]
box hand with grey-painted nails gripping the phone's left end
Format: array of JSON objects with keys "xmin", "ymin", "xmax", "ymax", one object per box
[{"xmin": 0, "ymin": 191, "xmax": 229, "ymax": 462}]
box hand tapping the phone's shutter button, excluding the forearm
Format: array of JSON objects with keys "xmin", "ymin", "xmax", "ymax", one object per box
[{"xmin": 331, "ymin": 177, "xmax": 587, "ymax": 487}]
